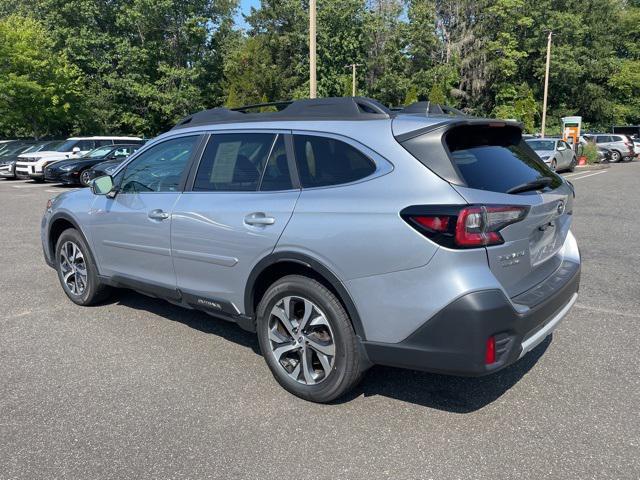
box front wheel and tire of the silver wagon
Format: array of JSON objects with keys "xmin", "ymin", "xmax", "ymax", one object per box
[{"xmin": 55, "ymin": 228, "xmax": 110, "ymax": 306}]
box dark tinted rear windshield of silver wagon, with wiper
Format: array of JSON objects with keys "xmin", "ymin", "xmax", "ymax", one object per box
[{"xmin": 445, "ymin": 125, "xmax": 562, "ymax": 193}]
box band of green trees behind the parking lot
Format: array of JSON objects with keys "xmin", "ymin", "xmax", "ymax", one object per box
[{"xmin": 0, "ymin": 0, "xmax": 640, "ymax": 136}]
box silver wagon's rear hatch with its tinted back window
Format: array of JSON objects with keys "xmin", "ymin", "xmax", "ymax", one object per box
[{"xmin": 401, "ymin": 121, "xmax": 573, "ymax": 297}]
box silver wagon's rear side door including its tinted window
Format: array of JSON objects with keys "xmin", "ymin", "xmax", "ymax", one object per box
[{"xmin": 171, "ymin": 131, "xmax": 300, "ymax": 314}]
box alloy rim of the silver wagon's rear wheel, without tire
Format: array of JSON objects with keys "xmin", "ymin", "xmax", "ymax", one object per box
[{"xmin": 269, "ymin": 296, "xmax": 336, "ymax": 385}]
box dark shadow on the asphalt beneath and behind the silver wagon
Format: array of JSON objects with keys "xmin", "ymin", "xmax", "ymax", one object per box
[{"xmin": 112, "ymin": 290, "xmax": 552, "ymax": 413}]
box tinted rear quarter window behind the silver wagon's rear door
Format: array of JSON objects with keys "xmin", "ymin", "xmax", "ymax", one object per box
[{"xmin": 294, "ymin": 135, "xmax": 376, "ymax": 188}]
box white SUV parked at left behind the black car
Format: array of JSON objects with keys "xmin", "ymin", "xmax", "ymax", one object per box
[{"xmin": 16, "ymin": 137, "xmax": 142, "ymax": 182}]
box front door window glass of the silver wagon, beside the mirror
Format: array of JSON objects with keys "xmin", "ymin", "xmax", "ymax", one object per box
[{"xmin": 118, "ymin": 135, "xmax": 199, "ymax": 193}]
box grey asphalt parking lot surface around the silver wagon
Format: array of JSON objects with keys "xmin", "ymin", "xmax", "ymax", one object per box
[{"xmin": 0, "ymin": 162, "xmax": 640, "ymax": 480}]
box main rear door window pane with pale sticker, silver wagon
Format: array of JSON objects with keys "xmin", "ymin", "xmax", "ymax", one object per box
[{"xmin": 193, "ymin": 133, "xmax": 276, "ymax": 192}]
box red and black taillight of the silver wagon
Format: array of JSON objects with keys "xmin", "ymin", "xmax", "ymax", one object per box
[{"xmin": 401, "ymin": 205, "xmax": 528, "ymax": 248}]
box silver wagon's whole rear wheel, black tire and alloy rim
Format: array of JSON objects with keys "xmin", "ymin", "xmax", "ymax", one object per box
[{"xmin": 256, "ymin": 275, "xmax": 363, "ymax": 403}]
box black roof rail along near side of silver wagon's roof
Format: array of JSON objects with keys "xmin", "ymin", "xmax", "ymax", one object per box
[{"xmin": 173, "ymin": 97, "xmax": 392, "ymax": 129}]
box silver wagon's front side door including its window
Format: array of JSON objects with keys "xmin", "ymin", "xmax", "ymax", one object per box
[{"xmin": 92, "ymin": 135, "xmax": 200, "ymax": 293}]
